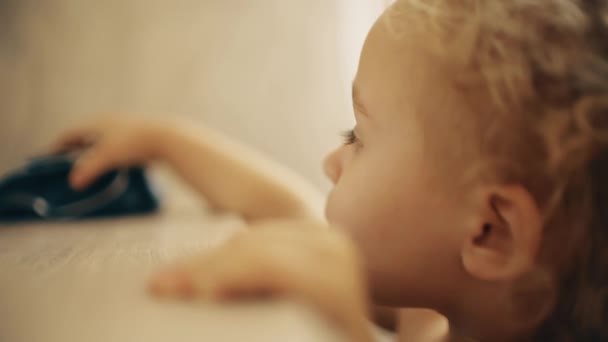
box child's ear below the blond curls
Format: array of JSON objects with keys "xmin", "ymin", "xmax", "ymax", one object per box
[{"xmin": 462, "ymin": 185, "xmax": 543, "ymax": 281}]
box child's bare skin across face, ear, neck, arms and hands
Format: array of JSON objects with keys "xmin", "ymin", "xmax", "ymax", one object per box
[{"xmin": 50, "ymin": 5, "xmax": 542, "ymax": 341}]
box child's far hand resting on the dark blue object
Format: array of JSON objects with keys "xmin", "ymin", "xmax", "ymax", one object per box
[{"xmin": 51, "ymin": 117, "xmax": 163, "ymax": 189}]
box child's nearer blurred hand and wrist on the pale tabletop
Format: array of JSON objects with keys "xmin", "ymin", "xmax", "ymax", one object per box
[{"xmin": 151, "ymin": 221, "xmax": 370, "ymax": 341}]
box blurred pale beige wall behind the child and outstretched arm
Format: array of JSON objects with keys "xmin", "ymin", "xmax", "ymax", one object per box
[{"xmin": 0, "ymin": 0, "xmax": 386, "ymax": 189}]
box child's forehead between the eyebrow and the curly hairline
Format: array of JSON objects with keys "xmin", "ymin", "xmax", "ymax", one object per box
[{"xmin": 355, "ymin": 13, "xmax": 464, "ymax": 124}]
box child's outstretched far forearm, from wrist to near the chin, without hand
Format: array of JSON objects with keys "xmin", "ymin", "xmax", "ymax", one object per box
[{"xmin": 158, "ymin": 125, "xmax": 323, "ymax": 220}]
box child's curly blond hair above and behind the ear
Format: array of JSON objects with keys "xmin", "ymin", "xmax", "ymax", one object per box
[{"xmin": 388, "ymin": 0, "xmax": 608, "ymax": 341}]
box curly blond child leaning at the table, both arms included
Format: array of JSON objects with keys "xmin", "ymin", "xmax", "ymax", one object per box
[{"xmin": 51, "ymin": 0, "xmax": 608, "ymax": 342}]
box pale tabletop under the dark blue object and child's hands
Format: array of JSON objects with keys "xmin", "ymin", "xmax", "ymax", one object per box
[{"xmin": 0, "ymin": 174, "xmax": 339, "ymax": 342}]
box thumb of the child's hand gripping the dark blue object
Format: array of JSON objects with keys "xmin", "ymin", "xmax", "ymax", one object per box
[{"xmin": 69, "ymin": 148, "xmax": 114, "ymax": 190}]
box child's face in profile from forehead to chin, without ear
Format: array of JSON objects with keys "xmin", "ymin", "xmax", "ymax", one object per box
[{"xmin": 325, "ymin": 10, "xmax": 462, "ymax": 305}]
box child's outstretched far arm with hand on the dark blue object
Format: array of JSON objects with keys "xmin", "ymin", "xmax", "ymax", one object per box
[{"xmin": 53, "ymin": 117, "xmax": 323, "ymax": 221}]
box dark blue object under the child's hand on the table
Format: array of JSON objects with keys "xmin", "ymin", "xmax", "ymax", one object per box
[{"xmin": 0, "ymin": 154, "xmax": 159, "ymax": 222}]
